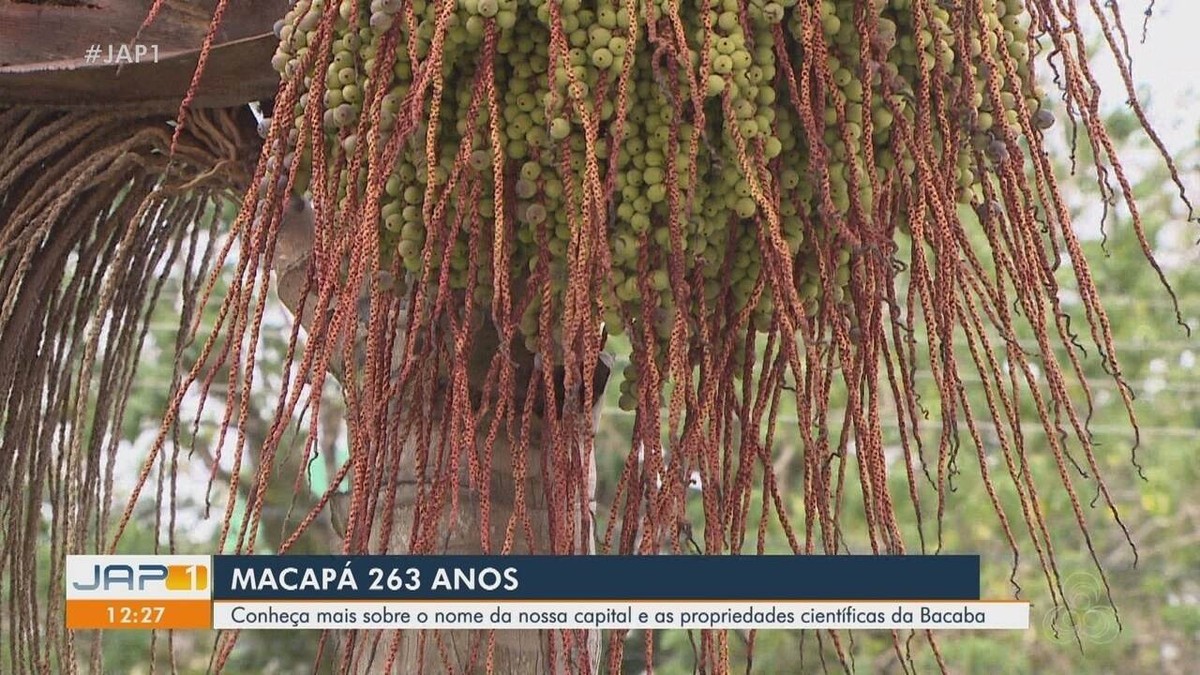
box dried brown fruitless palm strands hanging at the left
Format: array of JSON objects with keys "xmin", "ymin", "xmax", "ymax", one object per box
[{"xmin": 0, "ymin": 106, "xmax": 260, "ymax": 673}]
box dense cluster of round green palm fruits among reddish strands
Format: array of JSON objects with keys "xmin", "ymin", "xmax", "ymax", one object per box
[{"xmin": 272, "ymin": 0, "xmax": 1054, "ymax": 406}]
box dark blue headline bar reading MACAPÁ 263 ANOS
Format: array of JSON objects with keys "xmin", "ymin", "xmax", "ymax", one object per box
[{"xmin": 212, "ymin": 555, "xmax": 979, "ymax": 601}]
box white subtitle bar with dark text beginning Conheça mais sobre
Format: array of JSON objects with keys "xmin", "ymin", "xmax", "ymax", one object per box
[{"xmin": 212, "ymin": 601, "xmax": 1030, "ymax": 631}]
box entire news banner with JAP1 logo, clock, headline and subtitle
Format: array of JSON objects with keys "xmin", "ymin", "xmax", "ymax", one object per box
[{"xmin": 66, "ymin": 555, "xmax": 1030, "ymax": 629}]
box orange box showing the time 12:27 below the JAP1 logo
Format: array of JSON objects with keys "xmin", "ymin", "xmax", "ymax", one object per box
[{"xmin": 66, "ymin": 598, "xmax": 212, "ymax": 631}]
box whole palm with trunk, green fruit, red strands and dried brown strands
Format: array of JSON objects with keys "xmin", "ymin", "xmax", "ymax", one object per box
[{"xmin": 0, "ymin": 0, "xmax": 1174, "ymax": 673}]
